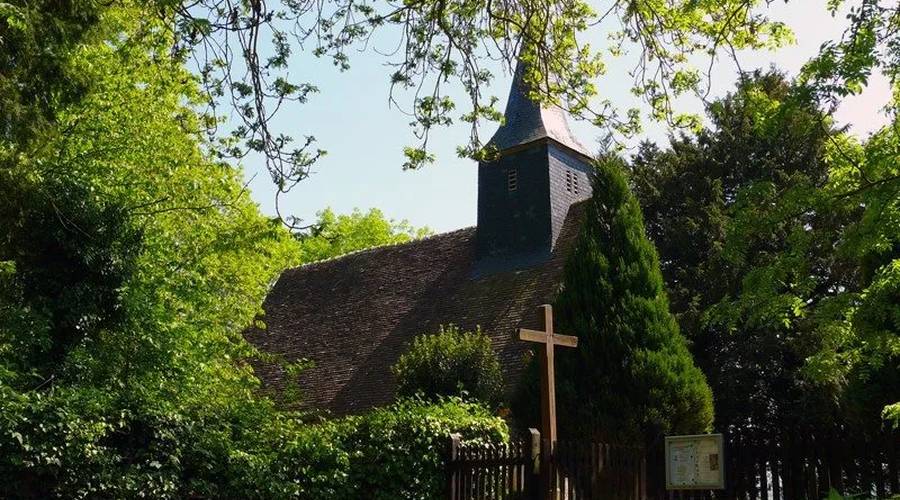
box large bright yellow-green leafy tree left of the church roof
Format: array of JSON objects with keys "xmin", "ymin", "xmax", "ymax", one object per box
[{"xmin": 0, "ymin": 4, "xmax": 304, "ymax": 498}]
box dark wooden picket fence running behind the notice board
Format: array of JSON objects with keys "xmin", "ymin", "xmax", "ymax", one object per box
[{"xmin": 447, "ymin": 430, "xmax": 900, "ymax": 500}]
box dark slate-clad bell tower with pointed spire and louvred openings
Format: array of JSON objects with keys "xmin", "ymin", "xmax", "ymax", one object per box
[{"xmin": 476, "ymin": 61, "xmax": 592, "ymax": 272}]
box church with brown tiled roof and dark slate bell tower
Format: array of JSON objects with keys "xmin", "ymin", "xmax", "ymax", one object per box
[{"xmin": 247, "ymin": 64, "xmax": 592, "ymax": 415}]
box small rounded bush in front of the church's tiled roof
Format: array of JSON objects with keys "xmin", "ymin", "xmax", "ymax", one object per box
[{"xmin": 392, "ymin": 325, "xmax": 503, "ymax": 407}]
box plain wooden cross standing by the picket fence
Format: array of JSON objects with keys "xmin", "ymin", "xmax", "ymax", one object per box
[{"xmin": 519, "ymin": 304, "xmax": 578, "ymax": 449}]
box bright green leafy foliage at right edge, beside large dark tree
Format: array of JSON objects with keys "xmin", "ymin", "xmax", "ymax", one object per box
[{"xmin": 824, "ymin": 103, "xmax": 900, "ymax": 428}]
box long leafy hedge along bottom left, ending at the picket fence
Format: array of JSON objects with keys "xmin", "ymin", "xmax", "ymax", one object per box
[{"xmin": 0, "ymin": 396, "xmax": 508, "ymax": 500}]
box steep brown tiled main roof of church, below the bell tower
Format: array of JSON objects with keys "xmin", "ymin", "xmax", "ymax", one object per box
[{"xmin": 247, "ymin": 204, "xmax": 583, "ymax": 415}]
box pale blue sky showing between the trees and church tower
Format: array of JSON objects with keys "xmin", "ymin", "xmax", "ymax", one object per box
[{"xmin": 243, "ymin": 0, "xmax": 889, "ymax": 232}]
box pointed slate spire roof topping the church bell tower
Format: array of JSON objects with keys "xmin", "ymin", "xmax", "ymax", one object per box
[{"xmin": 488, "ymin": 60, "xmax": 593, "ymax": 158}]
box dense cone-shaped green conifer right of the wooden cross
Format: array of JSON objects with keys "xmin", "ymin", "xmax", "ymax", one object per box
[{"xmin": 556, "ymin": 159, "xmax": 713, "ymax": 445}]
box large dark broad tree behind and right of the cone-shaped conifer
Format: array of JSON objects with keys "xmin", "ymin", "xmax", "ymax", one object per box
[{"xmin": 631, "ymin": 72, "xmax": 854, "ymax": 439}]
